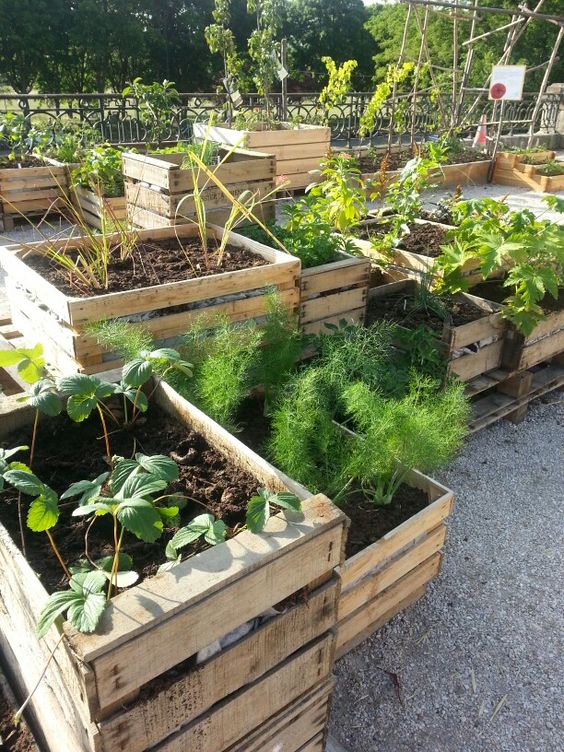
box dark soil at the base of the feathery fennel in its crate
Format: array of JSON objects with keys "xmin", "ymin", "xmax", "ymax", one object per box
[{"xmin": 341, "ymin": 484, "xmax": 429, "ymax": 557}]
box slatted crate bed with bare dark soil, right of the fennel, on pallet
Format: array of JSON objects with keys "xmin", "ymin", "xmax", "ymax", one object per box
[{"xmin": 366, "ymin": 280, "xmax": 506, "ymax": 381}]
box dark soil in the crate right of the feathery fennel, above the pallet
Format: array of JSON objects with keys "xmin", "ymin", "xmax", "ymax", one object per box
[{"xmin": 366, "ymin": 290, "xmax": 483, "ymax": 333}]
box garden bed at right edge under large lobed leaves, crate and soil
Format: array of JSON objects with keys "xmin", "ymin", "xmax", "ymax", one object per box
[{"xmin": 476, "ymin": 282, "xmax": 564, "ymax": 371}]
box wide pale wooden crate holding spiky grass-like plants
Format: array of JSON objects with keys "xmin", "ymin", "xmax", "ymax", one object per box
[{"xmin": 0, "ymin": 225, "xmax": 300, "ymax": 373}]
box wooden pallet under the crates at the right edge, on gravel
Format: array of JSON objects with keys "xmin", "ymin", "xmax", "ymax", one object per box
[{"xmin": 466, "ymin": 354, "xmax": 564, "ymax": 433}]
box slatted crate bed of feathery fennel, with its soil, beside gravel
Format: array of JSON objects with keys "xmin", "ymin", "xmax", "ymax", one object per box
[{"xmin": 236, "ymin": 400, "xmax": 453, "ymax": 657}]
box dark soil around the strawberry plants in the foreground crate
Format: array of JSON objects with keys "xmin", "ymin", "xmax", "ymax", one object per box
[{"xmin": 0, "ymin": 405, "xmax": 258, "ymax": 591}]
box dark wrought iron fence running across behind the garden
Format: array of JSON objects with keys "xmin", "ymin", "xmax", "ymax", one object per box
[{"xmin": 0, "ymin": 90, "xmax": 560, "ymax": 145}]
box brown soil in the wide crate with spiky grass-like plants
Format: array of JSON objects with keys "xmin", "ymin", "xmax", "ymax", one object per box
[{"xmin": 24, "ymin": 238, "xmax": 269, "ymax": 297}]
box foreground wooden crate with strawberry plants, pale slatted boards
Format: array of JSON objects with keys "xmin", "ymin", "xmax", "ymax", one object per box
[{"xmin": 0, "ymin": 383, "xmax": 347, "ymax": 752}]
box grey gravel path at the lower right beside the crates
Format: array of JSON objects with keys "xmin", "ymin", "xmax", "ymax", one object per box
[{"xmin": 331, "ymin": 392, "xmax": 564, "ymax": 752}]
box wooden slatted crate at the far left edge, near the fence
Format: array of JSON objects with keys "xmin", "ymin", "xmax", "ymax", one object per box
[{"xmin": 0, "ymin": 157, "xmax": 75, "ymax": 231}]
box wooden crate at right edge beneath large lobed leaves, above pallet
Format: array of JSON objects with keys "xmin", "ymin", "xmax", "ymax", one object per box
[{"xmin": 502, "ymin": 310, "xmax": 564, "ymax": 371}]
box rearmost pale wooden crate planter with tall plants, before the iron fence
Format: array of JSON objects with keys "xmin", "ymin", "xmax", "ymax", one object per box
[{"xmin": 194, "ymin": 123, "xmax": 331, "ymax": 190}]
